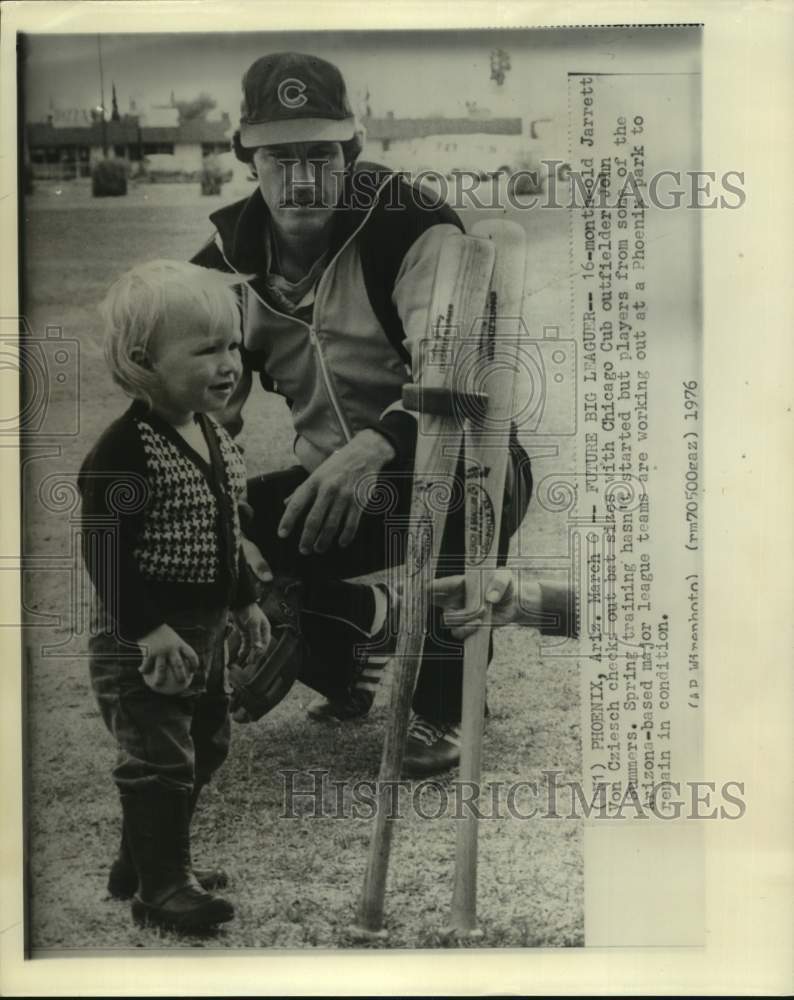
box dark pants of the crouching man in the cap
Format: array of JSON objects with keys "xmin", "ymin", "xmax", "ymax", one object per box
[{"xmin": 248, "ymin": 437, "xmax": 532, "ymax": 722}]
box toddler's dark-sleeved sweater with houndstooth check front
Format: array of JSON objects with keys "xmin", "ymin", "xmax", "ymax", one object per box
[{"xmin": 79, "ymin": 402, "xmax": 255, "ymax": 639}]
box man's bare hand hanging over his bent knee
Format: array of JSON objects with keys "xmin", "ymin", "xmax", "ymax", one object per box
[{"xmin": 278, "ymin": 429, "xmax": 394, "ymax": 555}]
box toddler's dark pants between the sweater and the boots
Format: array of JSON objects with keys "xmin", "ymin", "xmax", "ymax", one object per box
[{"xmin": 89, "ymin": 609, "xmax": 230, "ymax": 792}]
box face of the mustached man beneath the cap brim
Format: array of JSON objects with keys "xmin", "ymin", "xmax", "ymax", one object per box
[{"xmin": 254, "ymin": 142, "xmax": 345, "ymax": 239}]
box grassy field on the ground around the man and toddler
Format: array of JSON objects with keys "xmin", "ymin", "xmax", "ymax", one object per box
[{"xmin": 22, "ymin": 176, "xmax": 583, "ymax": 953}]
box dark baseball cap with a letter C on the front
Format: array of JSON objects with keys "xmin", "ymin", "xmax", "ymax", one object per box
[{"xmin": 240, "ymin": 52, "xmax": 356, "ymax": 149}]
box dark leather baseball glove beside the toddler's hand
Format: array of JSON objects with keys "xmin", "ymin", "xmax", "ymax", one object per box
[{"xmin": 227, "ymin": 577, "xmax": 306, "ymax": 722}]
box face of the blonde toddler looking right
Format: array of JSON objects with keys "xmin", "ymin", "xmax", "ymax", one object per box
[{"xmin": 149, "ymin": 300, "xmax": 242, "ymax": 420}]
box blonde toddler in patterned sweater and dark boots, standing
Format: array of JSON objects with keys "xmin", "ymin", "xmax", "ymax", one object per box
[{"xmin": 79, "ymin": 261, "xmax": 270, "ymax": 931}]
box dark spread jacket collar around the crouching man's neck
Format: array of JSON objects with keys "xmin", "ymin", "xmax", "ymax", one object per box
[{"xmin": 210, "ymin": 163, "xmax": 399, "ymax": 274}]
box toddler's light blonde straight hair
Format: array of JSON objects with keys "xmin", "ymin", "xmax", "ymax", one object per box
[{"xmin": 99, "ymin": 260, "xmax": 244, "ymax": 406}]
